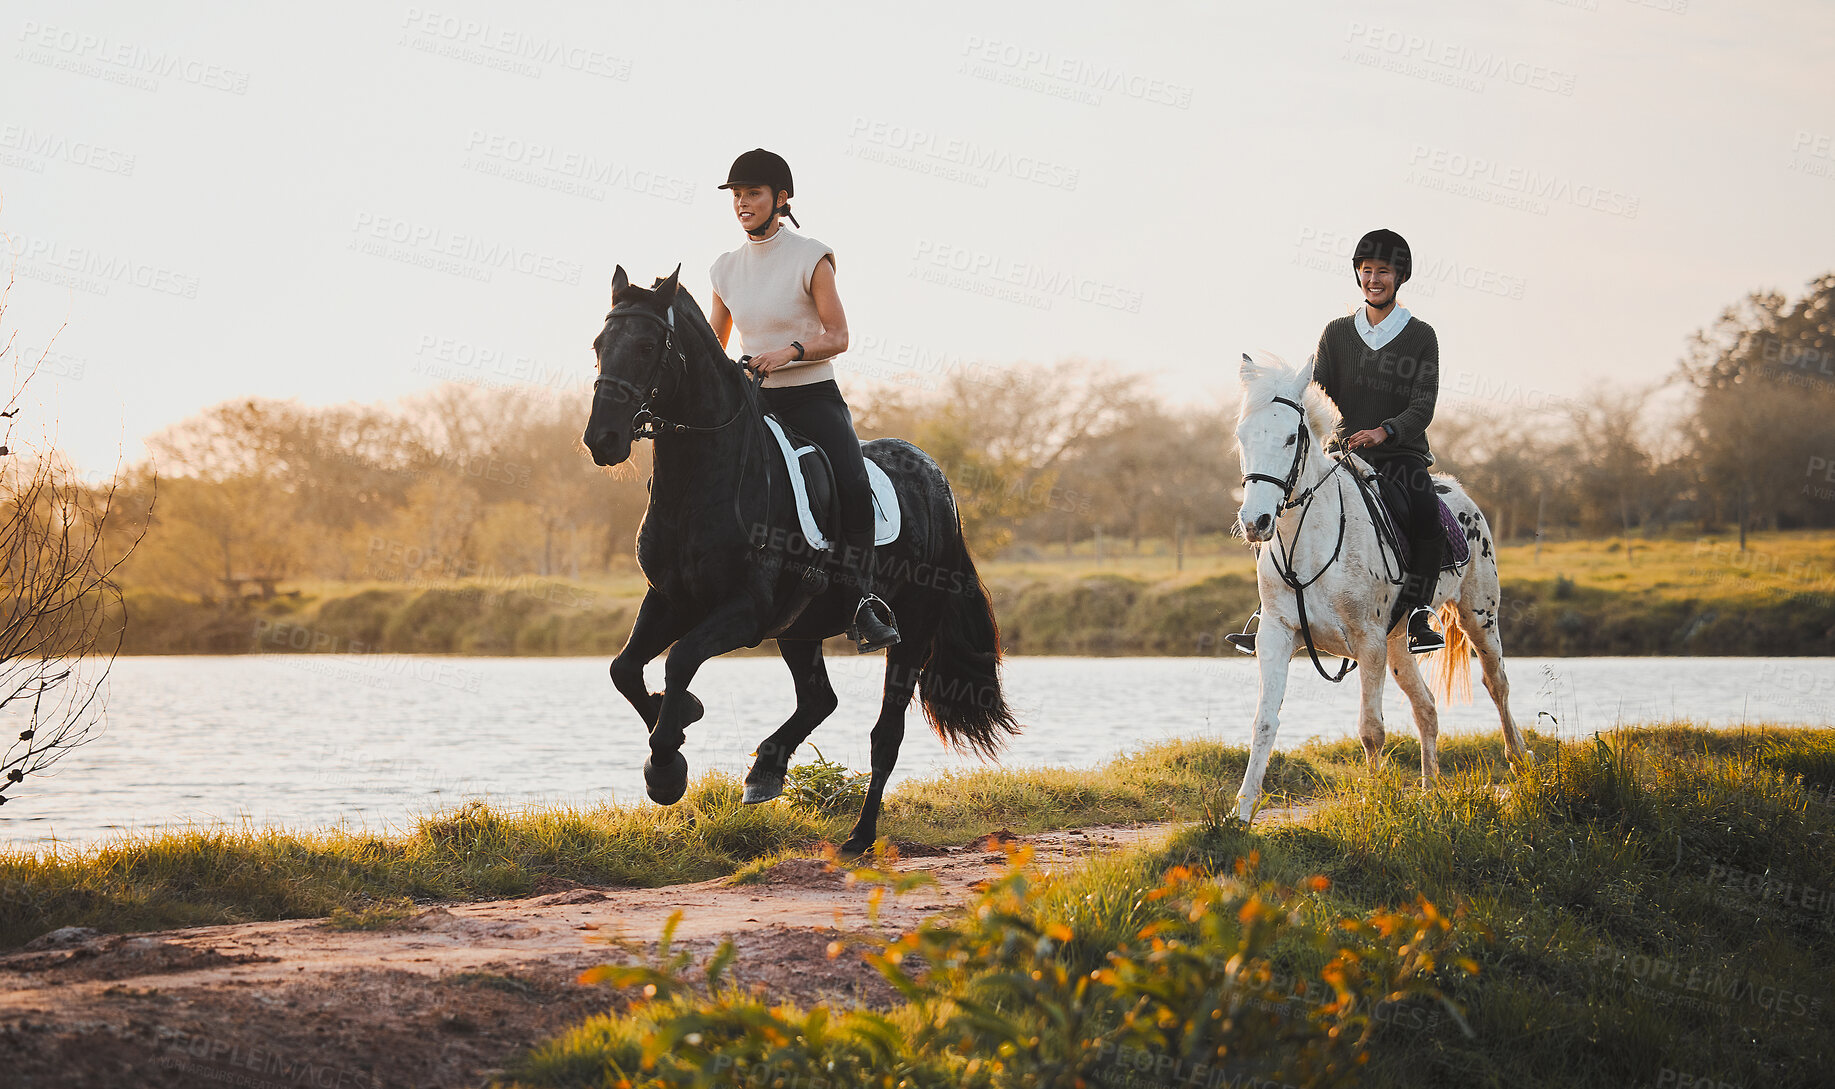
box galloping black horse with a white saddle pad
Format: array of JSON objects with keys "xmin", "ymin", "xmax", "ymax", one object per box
[{"xmin": 585, "ymin": 266, "xmax": 1018, "ymax": 854}]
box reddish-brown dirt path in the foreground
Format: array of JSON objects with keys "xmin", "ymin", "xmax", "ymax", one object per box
[{"xmin": 0, "ymin": 814, "xmax": 1218, "ymax": 1089}]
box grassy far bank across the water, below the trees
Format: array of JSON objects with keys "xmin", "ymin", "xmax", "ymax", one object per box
[{"xmin": 123, "ymin": 531, "xmax": 1835, "ymax": 656}]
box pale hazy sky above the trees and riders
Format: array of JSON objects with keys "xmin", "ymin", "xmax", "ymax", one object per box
[{"xmin": 0, "ymin": 0, "xmax": 1835, "ymax": 468}]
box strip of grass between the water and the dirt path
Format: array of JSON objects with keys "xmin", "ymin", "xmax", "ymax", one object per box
[{"xmin": 0, "ymin": 742, "xmax": 1316, "ymax": 948}]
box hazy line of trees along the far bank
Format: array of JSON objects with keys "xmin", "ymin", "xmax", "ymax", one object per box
[{"xmin": 89, "ymin": 274, "xmax": 1835, "ymax": 599}]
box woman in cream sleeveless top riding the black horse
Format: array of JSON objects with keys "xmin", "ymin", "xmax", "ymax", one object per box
[{"xmin": 708, "ymin": 147, "xmax": 899, "ymax": 654}]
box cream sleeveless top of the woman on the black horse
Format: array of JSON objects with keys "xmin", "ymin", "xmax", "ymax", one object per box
[{"xmin": 712, "ymin": 226, "xmax": 837, "ymax": 387}]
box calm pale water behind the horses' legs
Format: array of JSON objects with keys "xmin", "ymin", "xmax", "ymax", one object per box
[{"xmin": 0, "ymin": 654, "xmax": 1835, "ymax": 847}]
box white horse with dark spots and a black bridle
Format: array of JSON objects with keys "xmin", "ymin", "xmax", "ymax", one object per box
[{"xmin": 1237, "ymin": 356, "xmax": 1527, "ymax": 821}]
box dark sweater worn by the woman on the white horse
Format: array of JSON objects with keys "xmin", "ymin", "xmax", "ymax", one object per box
[{"xmin": 1312, "ymin": 314, "xmax": 1440, "ymax": 465}]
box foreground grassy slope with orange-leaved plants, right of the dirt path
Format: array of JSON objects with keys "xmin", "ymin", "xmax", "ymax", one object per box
[{"xmin": 514, "ymin": 727, "xmax": 1835, "ymax": 1089}]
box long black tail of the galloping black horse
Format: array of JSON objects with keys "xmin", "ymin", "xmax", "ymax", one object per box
[{"xmin": 918, "ymin": 516, "xmax": 1020, "ymax": 758}]
